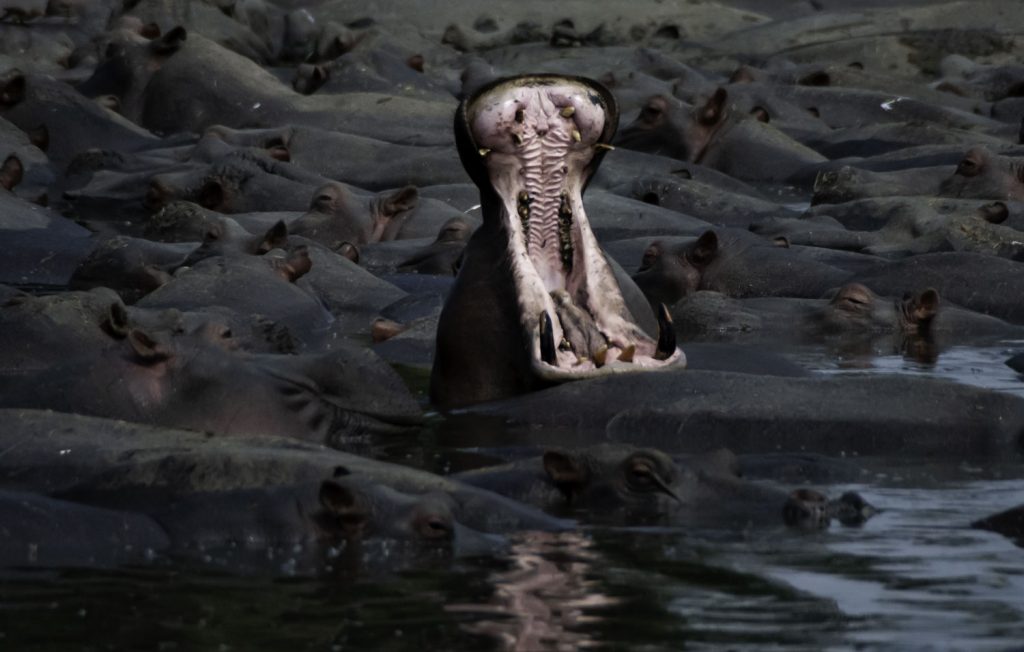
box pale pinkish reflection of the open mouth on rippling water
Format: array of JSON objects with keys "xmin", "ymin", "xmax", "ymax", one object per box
[{"xmin": 446, "ymin": 532, "xmax": 617, "ymax": 651}]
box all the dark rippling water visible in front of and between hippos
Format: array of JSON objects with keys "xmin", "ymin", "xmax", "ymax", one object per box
[{"xmin": 0, "ymin": 342, "xmax": 1024, "ymax": 651}]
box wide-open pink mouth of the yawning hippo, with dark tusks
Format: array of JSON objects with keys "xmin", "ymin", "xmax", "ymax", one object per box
[{"xmin": 456, "ymin": 75, "xmax": 685, "ymax": 382}]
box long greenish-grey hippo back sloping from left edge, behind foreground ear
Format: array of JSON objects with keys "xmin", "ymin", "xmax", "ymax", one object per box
[{"xmin": 0, "ymin": 409, "xmax": 573, "ymax": 546}]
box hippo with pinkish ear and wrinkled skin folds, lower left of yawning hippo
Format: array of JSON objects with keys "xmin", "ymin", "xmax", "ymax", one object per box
[{"xmin": 0, "ymin": 329, "xmax": 421, "ymax": 446}]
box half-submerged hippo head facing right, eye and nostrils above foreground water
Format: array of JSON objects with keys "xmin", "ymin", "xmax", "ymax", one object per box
[{"xmin": 454, "ymin": 444, "xmax": 873, "ymax": 529}]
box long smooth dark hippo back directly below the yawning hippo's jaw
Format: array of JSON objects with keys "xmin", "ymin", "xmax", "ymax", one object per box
[{"xmin": 465, "ymin": 368, "xmax": 1024, "ymax": 460}]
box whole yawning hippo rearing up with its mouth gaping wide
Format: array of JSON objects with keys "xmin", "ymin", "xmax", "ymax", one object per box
[{"xmin": 430, "ymin": 75, "xmax": 685, "ymax": 407}]
